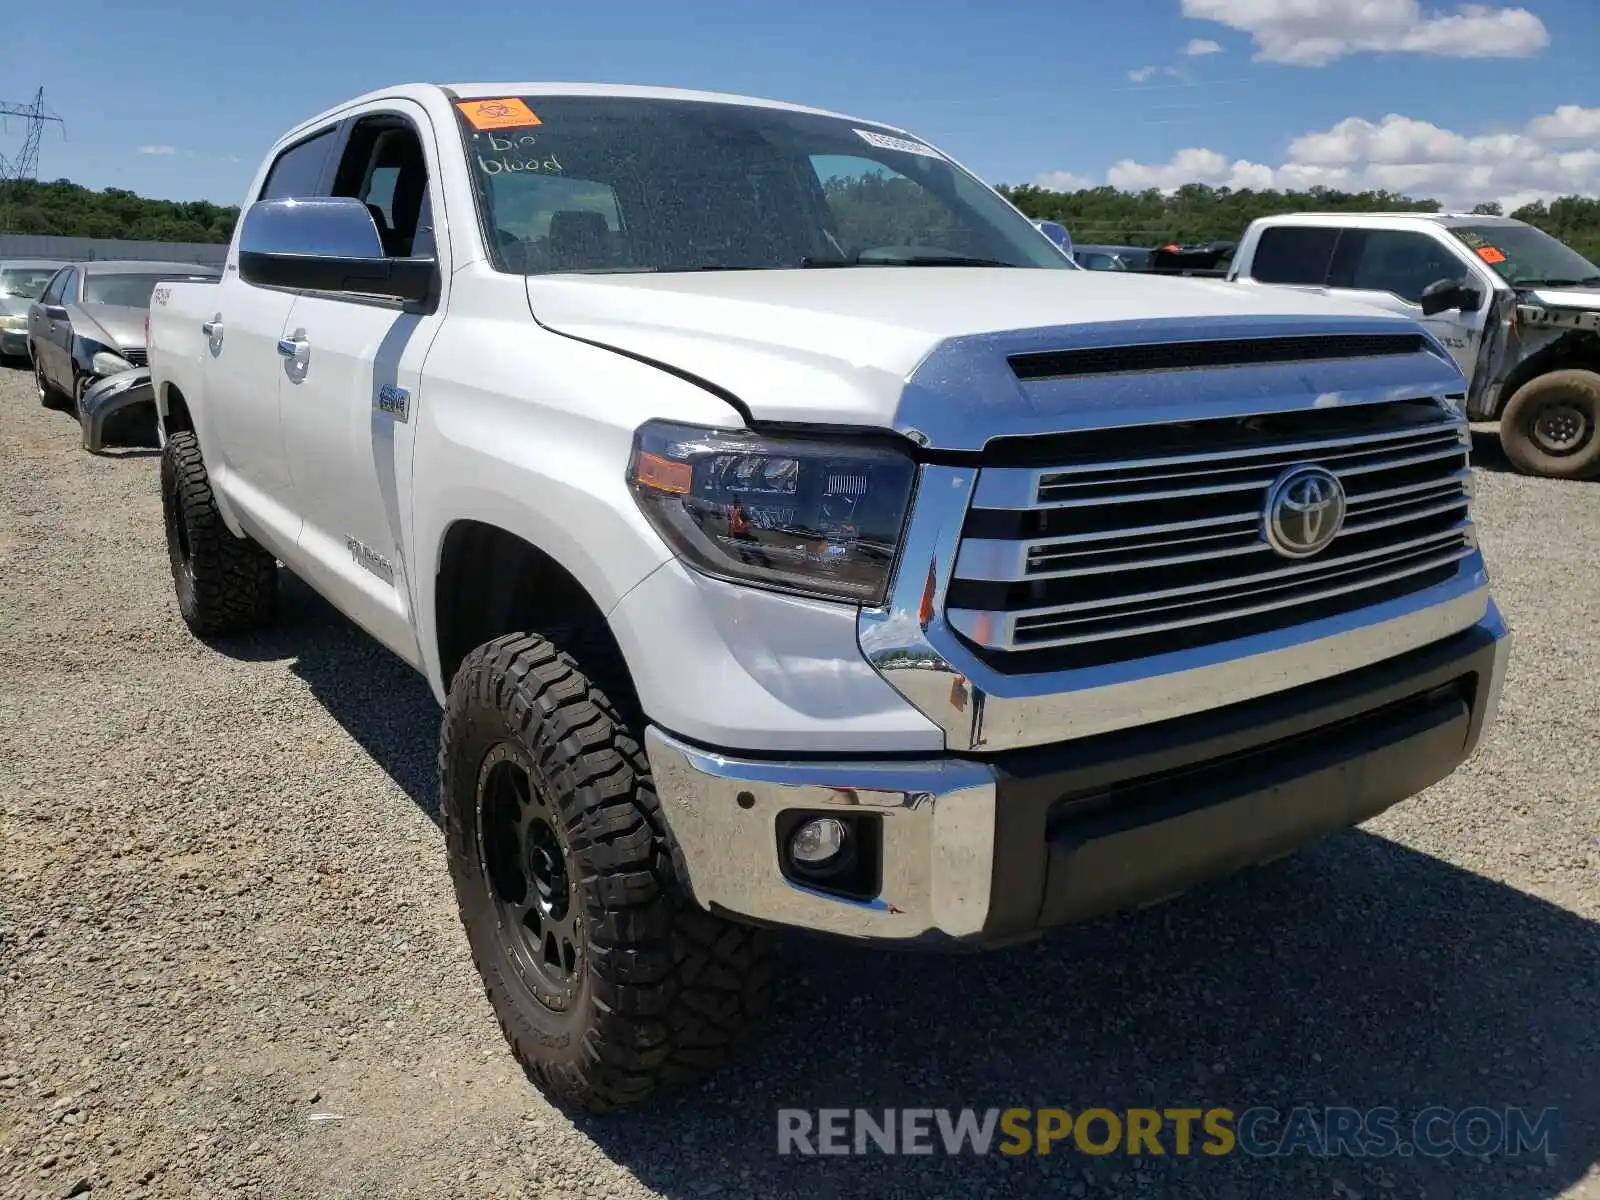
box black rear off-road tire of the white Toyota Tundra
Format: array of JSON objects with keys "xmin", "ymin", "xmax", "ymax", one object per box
[{"xmin": 162, "ymin": 434, "xmax": 278, "ymax": 637}]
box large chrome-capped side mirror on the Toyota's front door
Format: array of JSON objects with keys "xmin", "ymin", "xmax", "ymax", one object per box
[{"xmin": 238, "ymin": 195, "xmax": 438, "ymax": 304}]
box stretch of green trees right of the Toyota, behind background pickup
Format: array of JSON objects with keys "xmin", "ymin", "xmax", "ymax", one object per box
[{"xmin": 998, "ymin": 184, "xmax": 1600, "ymax": 262}]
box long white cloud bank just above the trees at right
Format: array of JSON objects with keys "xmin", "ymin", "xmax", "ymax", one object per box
[{"xmin": 1038, "ymin": 104, "xmax": 1600, "ymax": 213}]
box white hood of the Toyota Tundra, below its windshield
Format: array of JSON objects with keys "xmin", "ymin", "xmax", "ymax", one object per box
[{"xmin": 528, "ymin": 267, "xmax": 1440, "ymax": 429}]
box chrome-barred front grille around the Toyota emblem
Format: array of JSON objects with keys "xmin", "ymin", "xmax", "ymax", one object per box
[{"xmin": 946, "ymin": 400, "xmax": 1475, "ymax": 670}]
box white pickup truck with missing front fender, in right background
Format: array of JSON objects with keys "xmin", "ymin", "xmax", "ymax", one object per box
[{"xmin": 1229, "ymin": 213, "xmax": 1600, "ymax": 478}]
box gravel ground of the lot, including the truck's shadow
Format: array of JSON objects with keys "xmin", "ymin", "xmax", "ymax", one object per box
[{"xmin": 0, "ymin": 371, "xmax": 1600, "ymax": 1200}]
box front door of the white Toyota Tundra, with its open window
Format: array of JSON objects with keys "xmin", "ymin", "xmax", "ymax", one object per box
[{"xmin": 282, "ymin": 101, "xmax": 450, "ymax": 662}]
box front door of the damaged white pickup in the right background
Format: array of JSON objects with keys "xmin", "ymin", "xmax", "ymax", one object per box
[{"xmin": 1328, "ymin": 229, "xmax": 1494, "ymax": 379}]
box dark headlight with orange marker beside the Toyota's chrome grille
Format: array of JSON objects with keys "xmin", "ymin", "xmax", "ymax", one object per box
[{"xmin": 627, "ymin": 421, "xmax": 917, "ymax": 605}]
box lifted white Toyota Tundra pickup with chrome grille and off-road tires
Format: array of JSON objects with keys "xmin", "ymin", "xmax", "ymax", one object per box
[{"xmin": 149, "ymin": 83, "xmax": 1510, "ymax": 1110}]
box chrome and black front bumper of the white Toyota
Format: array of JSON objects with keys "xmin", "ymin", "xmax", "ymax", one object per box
[{"xmin": 646, "ymin": 603, "xmax": 1510, "ymax": 944}]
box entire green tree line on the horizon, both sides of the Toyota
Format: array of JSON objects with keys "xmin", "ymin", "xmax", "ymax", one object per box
[{"xmin": 0, "ymin": 179, "xmax": 1600, "ymax": 262}]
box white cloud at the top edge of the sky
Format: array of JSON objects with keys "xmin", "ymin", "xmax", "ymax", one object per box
[{"xmin": 1182, "ymin": 0, "xmax": 1550, "ymax": 67}]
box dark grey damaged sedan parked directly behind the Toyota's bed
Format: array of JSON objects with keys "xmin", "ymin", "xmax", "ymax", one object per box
[{"xmin": 27, "ymin": 261, "xmax": 222, "ymax": 411}]
